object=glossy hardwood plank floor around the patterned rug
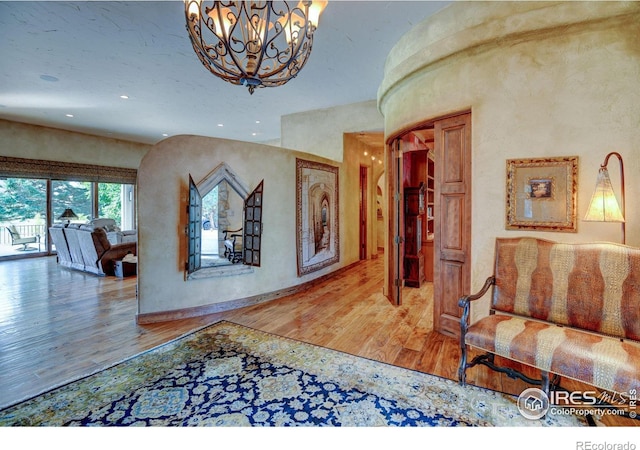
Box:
[0,253,640,426]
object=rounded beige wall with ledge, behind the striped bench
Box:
[378,2,640,324]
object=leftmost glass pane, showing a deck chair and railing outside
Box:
[0,178,47,256]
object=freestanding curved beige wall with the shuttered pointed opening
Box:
[138,136,370,314]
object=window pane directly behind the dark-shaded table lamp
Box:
[51,180,92,223]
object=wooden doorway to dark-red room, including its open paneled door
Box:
[385,112,471,336]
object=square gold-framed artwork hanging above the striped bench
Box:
[506,156,578,233]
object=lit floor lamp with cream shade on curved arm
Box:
[584,152,626,244]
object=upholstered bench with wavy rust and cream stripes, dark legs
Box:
[458,238,640,394]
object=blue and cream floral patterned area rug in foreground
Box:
[0,321,584,427]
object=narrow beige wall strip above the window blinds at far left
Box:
[0,120,151,169]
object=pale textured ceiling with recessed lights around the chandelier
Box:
[0,0,451,144]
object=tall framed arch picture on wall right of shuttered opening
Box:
[296,159,340,276]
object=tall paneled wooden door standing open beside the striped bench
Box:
[433,114,471,337]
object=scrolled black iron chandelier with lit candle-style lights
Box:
[185,0,327,94]
